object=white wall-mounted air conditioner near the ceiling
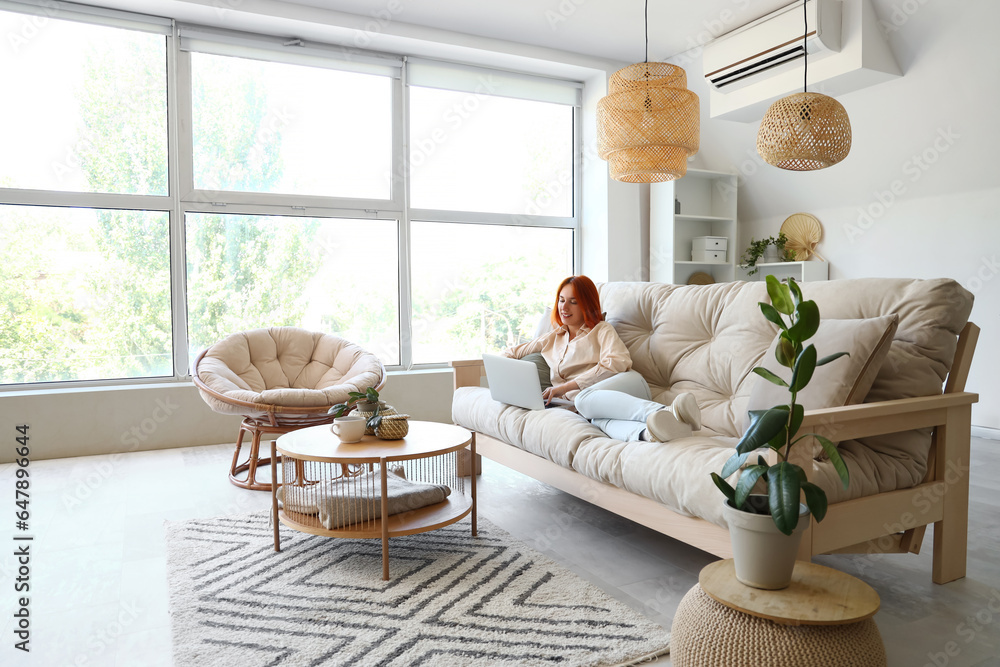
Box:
[704,0,842,93]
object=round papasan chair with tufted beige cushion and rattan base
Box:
[191,327,385,491]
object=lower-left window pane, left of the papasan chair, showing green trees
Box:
[0,205,173,384]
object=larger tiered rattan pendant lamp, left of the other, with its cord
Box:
[597,0,700,183]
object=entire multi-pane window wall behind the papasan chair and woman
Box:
[0,2,579,386]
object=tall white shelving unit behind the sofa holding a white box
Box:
[649,169,740,285]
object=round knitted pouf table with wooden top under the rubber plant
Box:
[670,559,886,667]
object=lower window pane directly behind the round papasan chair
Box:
[187,213,399,365]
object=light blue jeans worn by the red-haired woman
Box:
[573,371,667,442]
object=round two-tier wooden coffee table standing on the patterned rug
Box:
[271,421,477,580]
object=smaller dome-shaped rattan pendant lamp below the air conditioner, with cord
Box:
[757,0,851,171]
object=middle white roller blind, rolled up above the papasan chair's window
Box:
[180,25,403,77]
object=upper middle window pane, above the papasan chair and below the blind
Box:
[191,52,392,199]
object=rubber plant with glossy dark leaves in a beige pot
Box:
[712,275,849,589]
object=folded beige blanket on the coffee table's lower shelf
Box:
[277,467,451,530]
